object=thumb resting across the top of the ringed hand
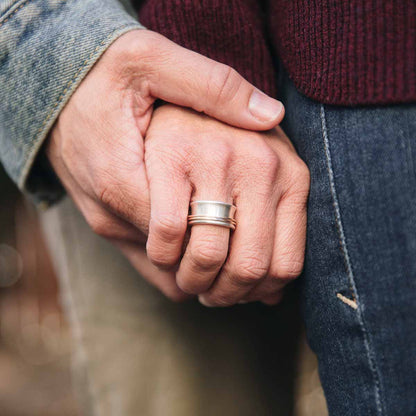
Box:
[143,31,284,130]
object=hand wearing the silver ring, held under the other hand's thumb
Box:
[145,105,309,306]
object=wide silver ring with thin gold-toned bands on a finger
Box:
[188,201,237,230]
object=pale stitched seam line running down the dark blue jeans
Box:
[321,104,383,415]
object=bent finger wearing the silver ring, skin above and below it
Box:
[176,185,232,294]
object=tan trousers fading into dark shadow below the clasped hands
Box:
[41,199,325,416]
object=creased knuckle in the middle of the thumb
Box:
[208,64,241,104]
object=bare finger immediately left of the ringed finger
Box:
[146,149,192,269]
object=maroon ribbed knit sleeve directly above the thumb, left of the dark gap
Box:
[139,0,276,96]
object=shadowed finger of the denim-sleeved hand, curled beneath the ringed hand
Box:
[114,241,191,302]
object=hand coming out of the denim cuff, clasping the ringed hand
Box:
[46,30,284,299]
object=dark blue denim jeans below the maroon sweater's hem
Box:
[280,75,416,416]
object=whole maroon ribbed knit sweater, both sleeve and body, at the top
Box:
[136,0,416,105]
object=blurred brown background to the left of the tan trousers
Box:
[0,165,80,416]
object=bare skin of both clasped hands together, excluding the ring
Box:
[46,30,309,306]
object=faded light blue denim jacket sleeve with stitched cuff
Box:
[0,0,143,205]
